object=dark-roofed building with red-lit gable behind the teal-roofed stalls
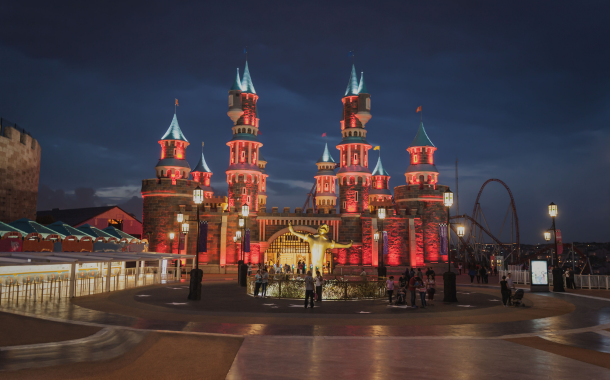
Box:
[36,206,142,239]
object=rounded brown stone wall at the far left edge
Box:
[0,127,41,223]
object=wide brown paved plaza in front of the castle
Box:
[0,275,610,379]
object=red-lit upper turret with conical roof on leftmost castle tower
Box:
[155,114,191,185]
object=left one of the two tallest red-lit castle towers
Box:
[226,62,263,211]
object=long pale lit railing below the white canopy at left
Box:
[0,266,191,305]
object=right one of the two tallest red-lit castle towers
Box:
[337,65,371,213]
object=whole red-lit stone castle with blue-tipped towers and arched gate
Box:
[142,62,448,273]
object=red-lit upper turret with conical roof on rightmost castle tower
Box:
[405,123,438,189]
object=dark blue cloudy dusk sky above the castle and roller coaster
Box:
[0,1,610,243]
